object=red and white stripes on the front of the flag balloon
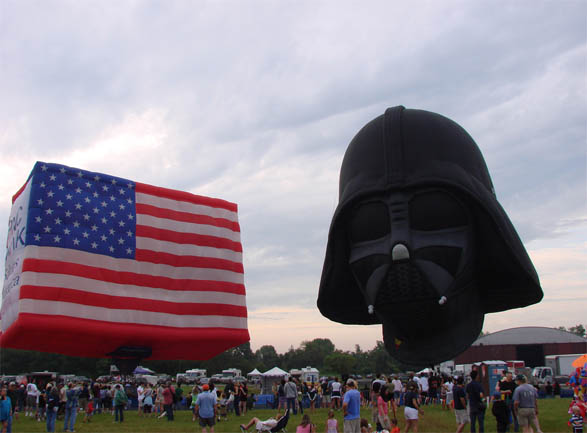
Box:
[13,183,247,330]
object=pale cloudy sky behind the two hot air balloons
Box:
[0,0,587,352]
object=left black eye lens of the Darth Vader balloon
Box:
[348,202,390,242]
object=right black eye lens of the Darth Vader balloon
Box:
[410,191,468,230]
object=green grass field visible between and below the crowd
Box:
[12,398,571,433]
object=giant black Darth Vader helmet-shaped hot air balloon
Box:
[318,106,542,365]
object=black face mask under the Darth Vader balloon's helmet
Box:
[347,189,475,341]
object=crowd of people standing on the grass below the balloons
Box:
[0,370,585,433]
